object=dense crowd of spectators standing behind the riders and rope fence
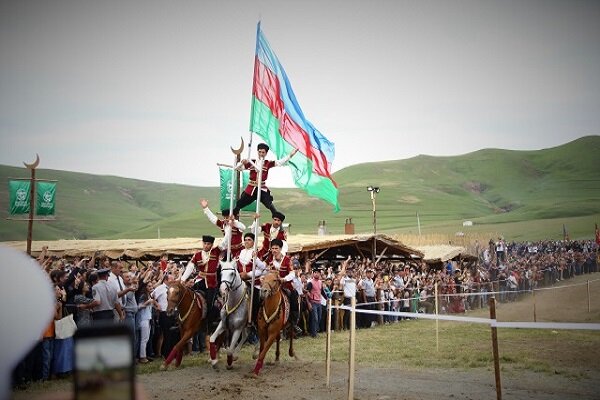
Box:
[13,239,598,390]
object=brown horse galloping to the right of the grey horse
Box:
[254,272,296,375]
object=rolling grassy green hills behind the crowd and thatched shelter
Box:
[0,136,600,240]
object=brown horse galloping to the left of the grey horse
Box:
[160,281,206,370]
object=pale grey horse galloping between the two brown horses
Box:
[210,261,249,369]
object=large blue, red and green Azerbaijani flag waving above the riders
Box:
[250,22,340,212]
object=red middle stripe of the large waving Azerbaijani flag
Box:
[252,57,337,182]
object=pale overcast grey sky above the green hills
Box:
[0,0,600,187]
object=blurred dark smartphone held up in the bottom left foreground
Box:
[73,323,135,400]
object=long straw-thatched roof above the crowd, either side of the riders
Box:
[1,235,423,259]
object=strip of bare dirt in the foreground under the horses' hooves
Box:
[127,359,600,400]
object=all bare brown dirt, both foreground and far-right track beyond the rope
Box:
[12,274,600,400]
